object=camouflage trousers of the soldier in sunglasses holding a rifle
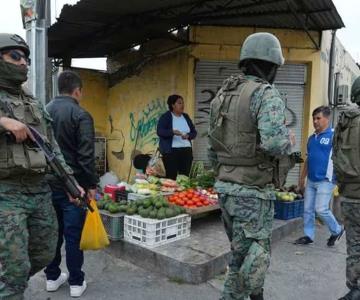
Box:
[0,184,58,300]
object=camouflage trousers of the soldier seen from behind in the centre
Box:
[219,194,274,300]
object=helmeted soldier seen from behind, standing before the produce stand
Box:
[209,33,295,300]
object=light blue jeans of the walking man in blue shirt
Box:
[304,179,341,240]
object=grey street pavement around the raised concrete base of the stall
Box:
[25,226,347,300]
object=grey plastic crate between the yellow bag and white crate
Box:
[99,210,125,241]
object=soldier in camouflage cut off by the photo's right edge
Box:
[333,77,360,300]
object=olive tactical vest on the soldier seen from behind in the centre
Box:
[209,76,274,187]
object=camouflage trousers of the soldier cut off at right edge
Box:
[341,197,360,289]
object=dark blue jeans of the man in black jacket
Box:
[45,191,86,285]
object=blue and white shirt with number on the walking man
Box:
[307,127,335,182]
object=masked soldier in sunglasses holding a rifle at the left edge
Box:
[0,33,76,300]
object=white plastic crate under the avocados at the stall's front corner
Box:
[124,214,191,248]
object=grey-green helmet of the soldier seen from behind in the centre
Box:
[240,32,285,66]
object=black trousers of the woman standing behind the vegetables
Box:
[163,147,193,180]
